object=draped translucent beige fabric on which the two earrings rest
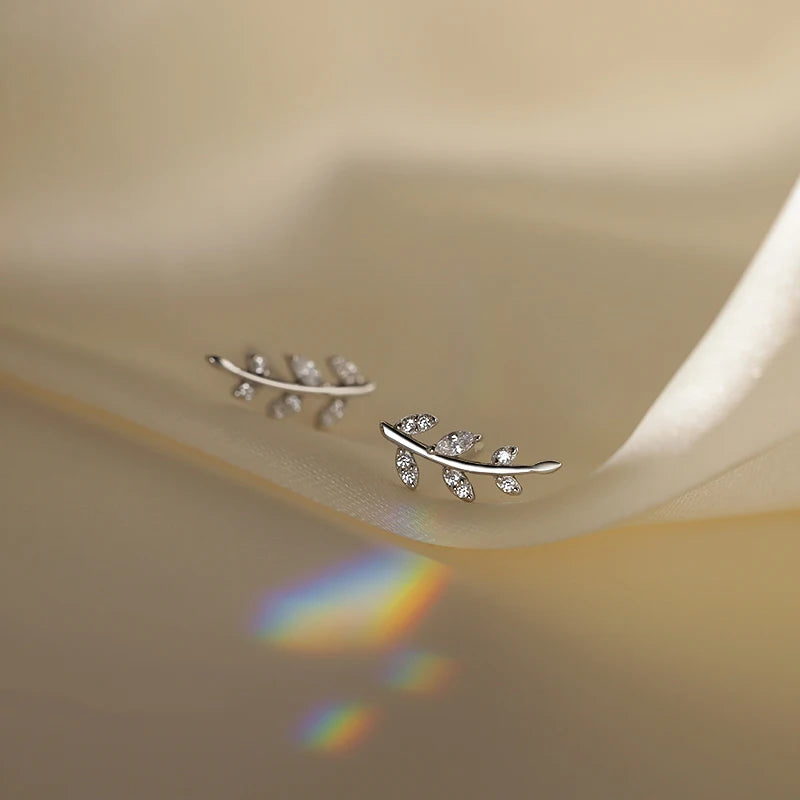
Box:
[0,0,800,547]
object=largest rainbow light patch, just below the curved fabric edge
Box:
[256,548,449,654]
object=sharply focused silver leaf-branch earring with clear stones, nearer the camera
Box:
[381,414,561,503]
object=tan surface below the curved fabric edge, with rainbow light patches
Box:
[0,386,800,800]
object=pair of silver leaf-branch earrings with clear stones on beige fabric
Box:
[207,353,561,503]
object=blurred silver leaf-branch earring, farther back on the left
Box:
[206,353,376,428]
